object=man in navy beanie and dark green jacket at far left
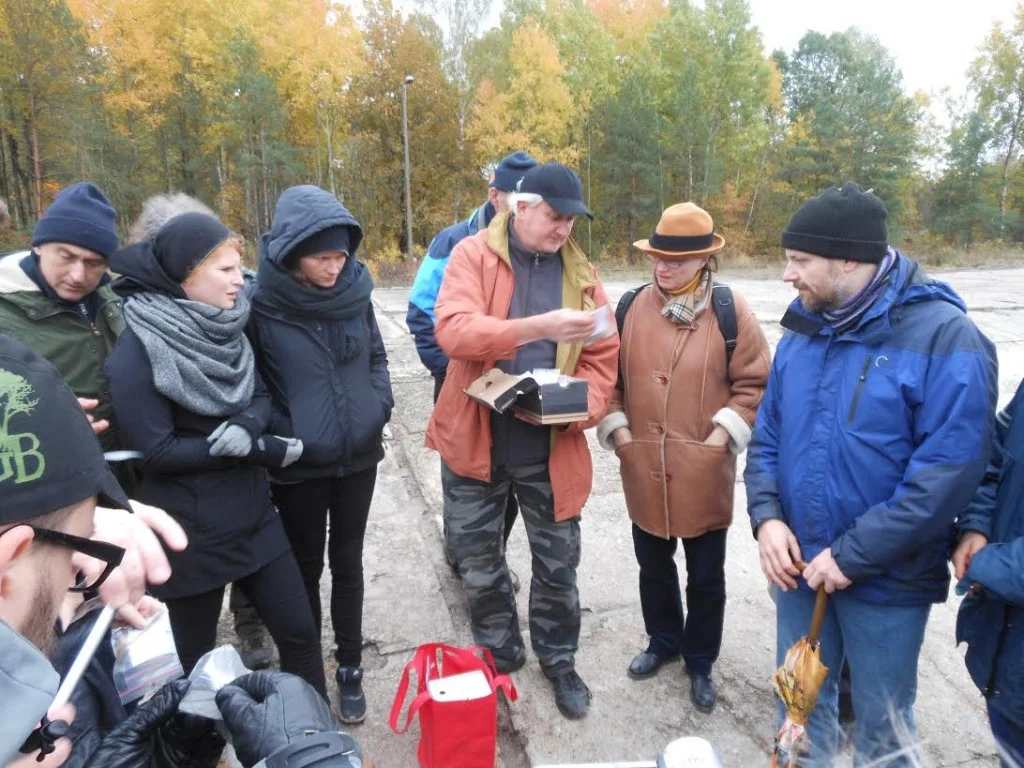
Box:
[0,181,130,462]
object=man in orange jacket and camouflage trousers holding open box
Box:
[426,163,618,719]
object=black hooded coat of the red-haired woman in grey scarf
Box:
[105,234,289,599]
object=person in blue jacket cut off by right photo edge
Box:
[953,383,1024,768]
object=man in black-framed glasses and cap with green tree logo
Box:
[0,336,180,765]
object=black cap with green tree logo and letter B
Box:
[0,336,131,525]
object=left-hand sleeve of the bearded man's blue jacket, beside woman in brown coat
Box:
[743,348,785,537]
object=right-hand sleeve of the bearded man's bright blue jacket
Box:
[831,325,998,582]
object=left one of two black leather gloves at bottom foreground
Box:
[86,680,224,768]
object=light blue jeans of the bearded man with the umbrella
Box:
[776,588,932,768]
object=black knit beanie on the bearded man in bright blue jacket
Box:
[782,183,889,264]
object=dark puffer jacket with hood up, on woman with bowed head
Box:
[249,185,394,482]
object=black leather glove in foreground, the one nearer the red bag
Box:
[216,672,337,768]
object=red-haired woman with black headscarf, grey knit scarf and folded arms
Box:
[106,213,327,697]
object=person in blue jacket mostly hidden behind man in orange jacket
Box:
[406,151,537,591]
